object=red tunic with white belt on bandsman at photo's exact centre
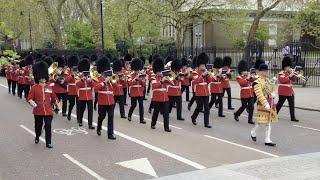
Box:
[151,76,169,102]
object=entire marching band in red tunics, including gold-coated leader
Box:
[1,53,303,148]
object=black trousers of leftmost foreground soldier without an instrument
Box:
[34,115,52,144]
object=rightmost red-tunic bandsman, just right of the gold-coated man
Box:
[276,56,299,122]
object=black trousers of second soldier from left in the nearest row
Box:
[97,105,114,135]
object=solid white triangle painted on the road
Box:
[116,158,158,177]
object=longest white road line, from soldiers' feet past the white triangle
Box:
[71,114,206,169]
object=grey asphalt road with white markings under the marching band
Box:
[0,78,320,180]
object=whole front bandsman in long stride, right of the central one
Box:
[191,53,211,128]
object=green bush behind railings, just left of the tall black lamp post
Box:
[67,23,95,49]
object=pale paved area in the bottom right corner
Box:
[152,152,320,180]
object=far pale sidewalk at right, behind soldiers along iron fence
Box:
[229,81,320,111]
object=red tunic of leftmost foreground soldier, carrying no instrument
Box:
[27,84,58,116]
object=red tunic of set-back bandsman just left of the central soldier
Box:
[128,74,146,97]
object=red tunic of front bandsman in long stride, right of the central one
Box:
[192,70,210,96]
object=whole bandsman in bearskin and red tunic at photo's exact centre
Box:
[151,56,172,132]
